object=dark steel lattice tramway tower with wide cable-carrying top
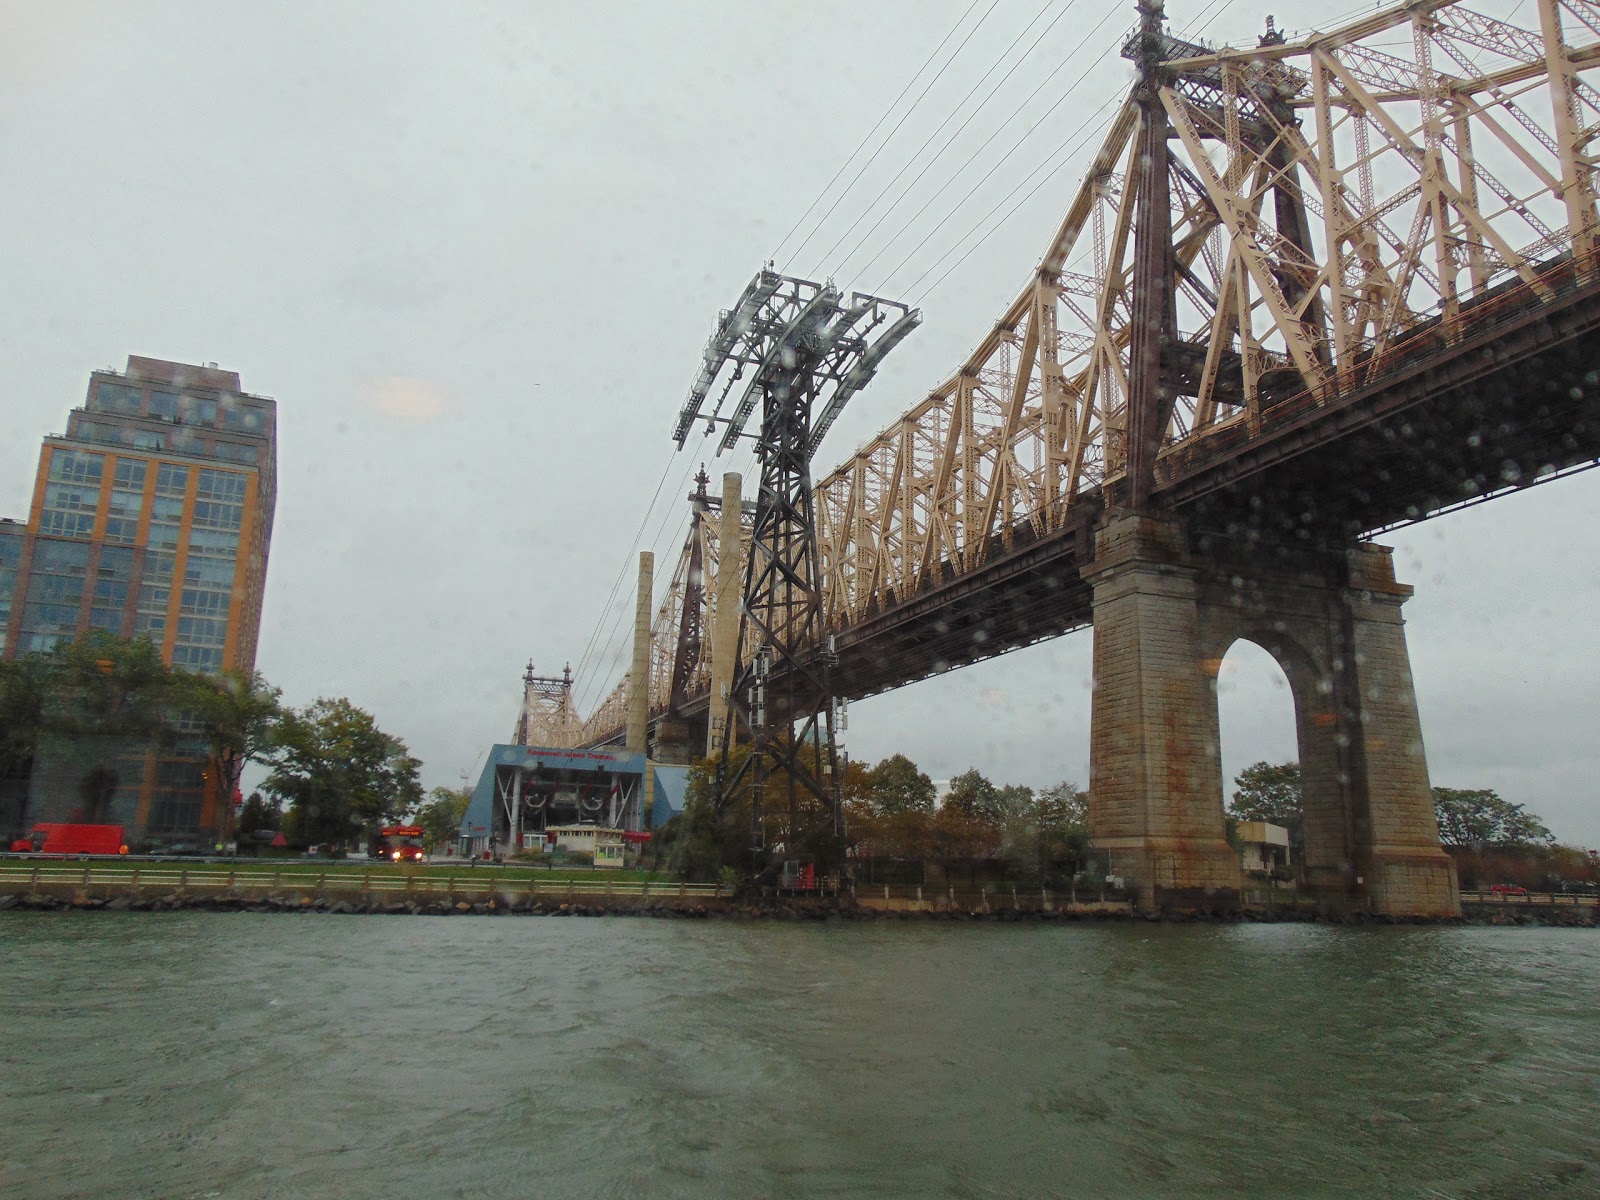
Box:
[674,270,922,875]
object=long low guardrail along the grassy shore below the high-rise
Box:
[0,862,723,899]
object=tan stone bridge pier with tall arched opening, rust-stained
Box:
[1085,514,1461,917]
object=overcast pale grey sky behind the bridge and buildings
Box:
[0,0,1600,845]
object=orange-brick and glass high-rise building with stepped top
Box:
[0,357,277,843]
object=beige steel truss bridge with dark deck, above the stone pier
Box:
[550,0,1600,761]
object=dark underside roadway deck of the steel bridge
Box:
[643,275,1600,732]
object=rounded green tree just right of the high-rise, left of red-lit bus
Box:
[262,698,422,846]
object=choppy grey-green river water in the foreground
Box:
[0,912,1600,1198]
